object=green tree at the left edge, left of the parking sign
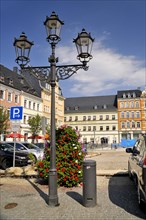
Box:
[0,106,10,134]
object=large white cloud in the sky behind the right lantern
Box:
[57,41,146,96]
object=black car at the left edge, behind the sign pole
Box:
[0,142,29,169]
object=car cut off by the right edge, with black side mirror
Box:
[126,136,146,208]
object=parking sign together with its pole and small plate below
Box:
[10,106,23,167]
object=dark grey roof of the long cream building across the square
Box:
[65,95,117,113]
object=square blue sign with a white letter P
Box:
[10,106,23,120]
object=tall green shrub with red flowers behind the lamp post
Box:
[37,125,84,187]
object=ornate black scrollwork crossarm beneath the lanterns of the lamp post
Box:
[21,64,89,82]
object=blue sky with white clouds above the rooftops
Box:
[0,0,146,97]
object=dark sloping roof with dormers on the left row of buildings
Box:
[0,65,40,97]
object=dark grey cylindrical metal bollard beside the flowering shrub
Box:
[83,160,97,207]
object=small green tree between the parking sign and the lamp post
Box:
[28,114,42,136]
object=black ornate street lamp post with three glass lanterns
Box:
[14,12,94,206]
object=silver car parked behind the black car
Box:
[6,141,44,161]
